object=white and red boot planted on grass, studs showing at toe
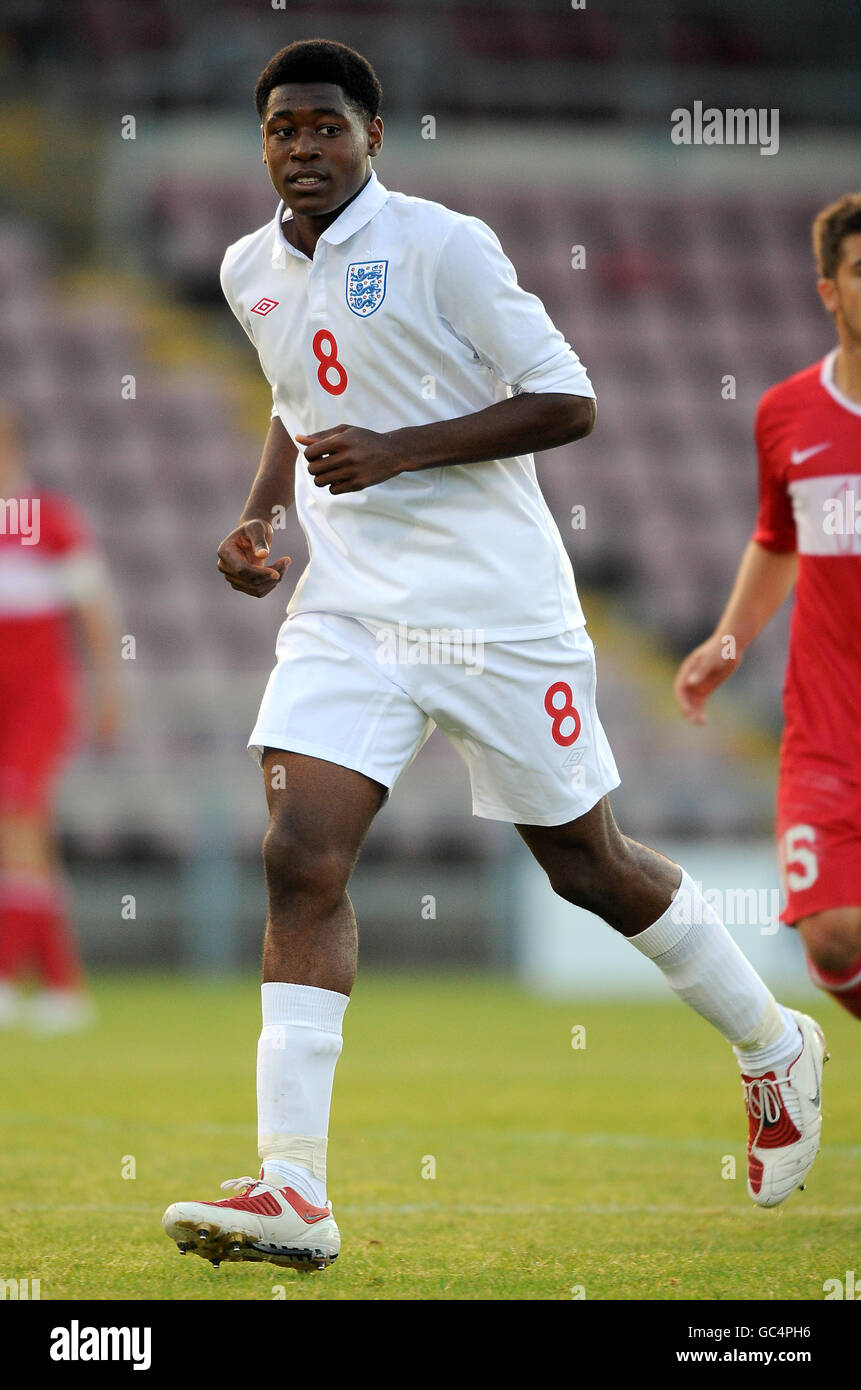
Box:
[161,1177,341,1272]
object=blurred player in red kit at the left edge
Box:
[0,407,118,1033]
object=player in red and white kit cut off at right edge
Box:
[676,193,861,1017]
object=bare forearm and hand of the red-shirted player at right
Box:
[675,541,798,724]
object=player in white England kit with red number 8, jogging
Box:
[163,40,825,1269]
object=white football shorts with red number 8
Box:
[249,613,619,826]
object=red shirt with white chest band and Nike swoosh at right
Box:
[754,349,861,784]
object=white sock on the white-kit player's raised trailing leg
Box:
[629,869,798,1076]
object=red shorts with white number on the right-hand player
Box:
[776,769,861,926]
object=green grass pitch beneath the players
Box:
[0,976,861,1300]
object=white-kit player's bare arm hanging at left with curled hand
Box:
[218,418,298,599]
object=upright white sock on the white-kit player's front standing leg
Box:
[257,984,349,1207]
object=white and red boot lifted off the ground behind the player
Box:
[741,1009,829,1207]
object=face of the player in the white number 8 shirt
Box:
[263,82,383,217]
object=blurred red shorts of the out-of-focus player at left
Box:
[0,673,77,815]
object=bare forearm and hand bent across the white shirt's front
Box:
[296,392,595,493]
